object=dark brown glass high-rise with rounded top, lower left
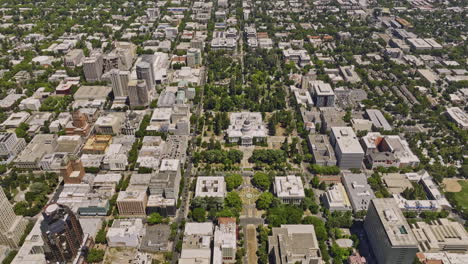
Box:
[41,203,84,263]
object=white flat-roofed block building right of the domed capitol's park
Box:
[330,127,364,169]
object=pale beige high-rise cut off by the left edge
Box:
[0,187,27,248]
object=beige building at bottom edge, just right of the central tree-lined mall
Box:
[268,225,322,264]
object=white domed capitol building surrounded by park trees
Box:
[226,112,267,146]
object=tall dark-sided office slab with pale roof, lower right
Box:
[364,198,419,264]
